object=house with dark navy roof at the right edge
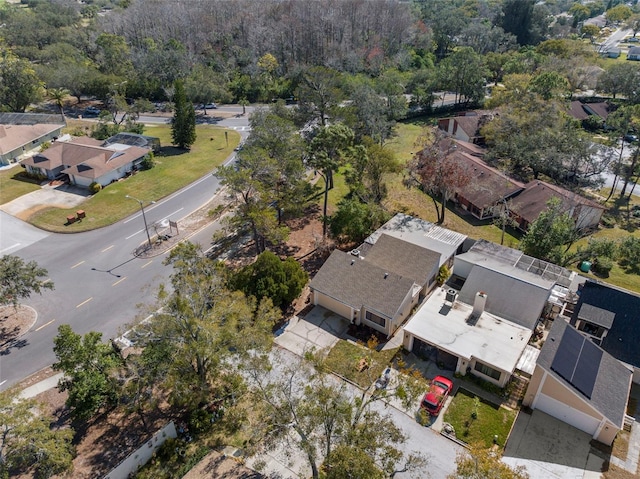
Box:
[571,280,640,384]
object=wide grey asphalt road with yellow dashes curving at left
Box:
[0,108,248,390]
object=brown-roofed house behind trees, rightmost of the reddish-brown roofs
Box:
[509,180,606,231]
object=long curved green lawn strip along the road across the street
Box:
[28,125,240,233]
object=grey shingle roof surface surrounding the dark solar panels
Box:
[538,319,632,427]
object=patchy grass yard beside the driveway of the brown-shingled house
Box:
[325,339,399,389]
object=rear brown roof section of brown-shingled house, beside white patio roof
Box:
[365,234,440,286]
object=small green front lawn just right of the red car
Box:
[444,388,516,448]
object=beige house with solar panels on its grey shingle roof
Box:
[523,319,632,445]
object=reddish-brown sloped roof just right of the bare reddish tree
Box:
[452,151,524,208]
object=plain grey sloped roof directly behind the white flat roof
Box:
[454,265,553,330]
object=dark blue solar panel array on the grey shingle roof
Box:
[551,326,602,399]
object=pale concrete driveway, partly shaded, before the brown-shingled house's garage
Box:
[274,306,349,356]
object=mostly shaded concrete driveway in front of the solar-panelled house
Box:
[502,410,604,479]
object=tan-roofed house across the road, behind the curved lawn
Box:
[22,137,150,187]
